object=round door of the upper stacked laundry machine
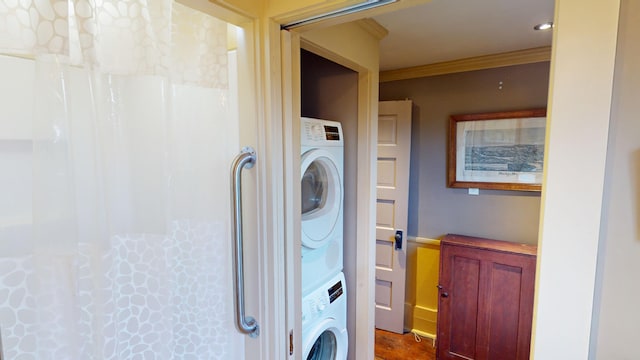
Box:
[300,149,342,249]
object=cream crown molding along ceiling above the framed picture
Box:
[380,46,551,83]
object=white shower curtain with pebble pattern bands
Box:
[0,0,243,360]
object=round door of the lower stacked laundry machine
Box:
[302,318,348,360]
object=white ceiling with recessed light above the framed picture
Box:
[373,0,554,71]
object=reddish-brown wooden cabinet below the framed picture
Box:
[437,235,536,360]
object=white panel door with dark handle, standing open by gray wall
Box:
[376,100,411,333]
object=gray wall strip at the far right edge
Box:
[589,0,640,359]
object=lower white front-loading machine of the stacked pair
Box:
[302,272,349,360]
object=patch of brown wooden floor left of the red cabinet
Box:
[375,329,436,360]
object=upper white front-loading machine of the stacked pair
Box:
[300,117,344,296]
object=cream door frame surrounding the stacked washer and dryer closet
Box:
[281,22,378,359]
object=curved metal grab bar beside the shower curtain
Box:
[231,147,260,337]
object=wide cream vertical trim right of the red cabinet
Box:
[531,0,620,359]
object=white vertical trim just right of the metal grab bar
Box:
[256,20,294,360]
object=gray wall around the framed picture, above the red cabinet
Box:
[380,62,549,244]
